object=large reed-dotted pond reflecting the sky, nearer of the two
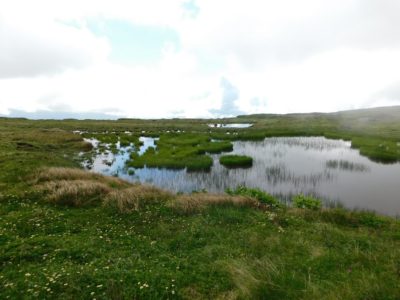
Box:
[83,137,400,216]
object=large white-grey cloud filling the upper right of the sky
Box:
[181,0,400,68]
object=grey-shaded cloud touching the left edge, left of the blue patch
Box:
[0,15,109,79]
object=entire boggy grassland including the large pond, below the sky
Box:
[0,108,400,299]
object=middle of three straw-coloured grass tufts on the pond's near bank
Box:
[104,185,173,213]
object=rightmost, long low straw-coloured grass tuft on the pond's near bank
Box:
[169,193,259,214]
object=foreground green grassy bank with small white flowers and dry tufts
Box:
[0,168,400,299]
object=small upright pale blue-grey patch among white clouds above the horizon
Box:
[209,78,243,117]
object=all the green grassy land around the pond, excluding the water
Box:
[0,107,400,299]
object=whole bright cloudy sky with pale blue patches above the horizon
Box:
[0,0,400,119]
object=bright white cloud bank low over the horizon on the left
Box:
[0,50,219,117]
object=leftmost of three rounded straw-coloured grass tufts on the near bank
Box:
[38,180,111,207]
